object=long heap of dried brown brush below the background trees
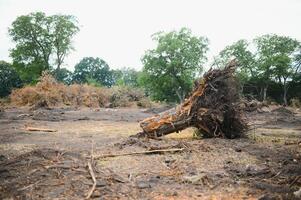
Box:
[10,73,151,110]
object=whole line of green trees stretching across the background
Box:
[0,12,301,105]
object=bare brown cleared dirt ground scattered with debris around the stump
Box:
[0,105,301,199]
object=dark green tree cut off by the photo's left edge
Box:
[0,61,22,97]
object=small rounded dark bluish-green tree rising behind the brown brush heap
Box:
[73,57,114,87]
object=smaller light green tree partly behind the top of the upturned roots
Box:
[214,40,258,92]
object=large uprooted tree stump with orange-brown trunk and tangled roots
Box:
[138,60,247,138]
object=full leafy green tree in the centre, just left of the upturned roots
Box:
[140,28,208,102]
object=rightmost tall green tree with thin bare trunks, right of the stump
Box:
[254,34,300,105]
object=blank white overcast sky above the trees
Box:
[0,0,301,70]
